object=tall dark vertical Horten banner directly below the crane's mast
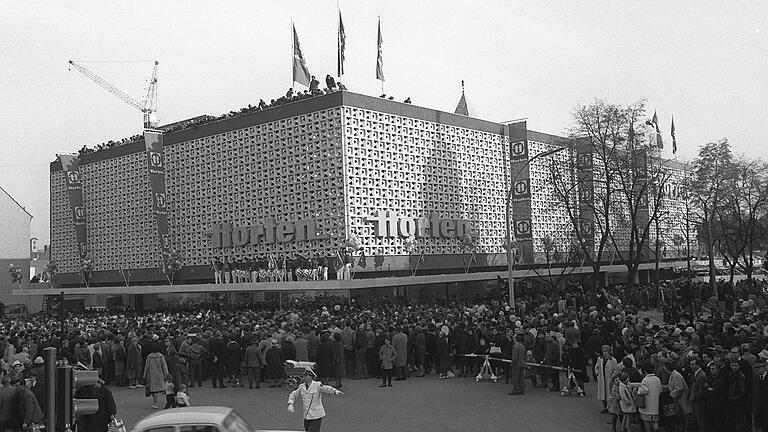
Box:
[144,130,170,256]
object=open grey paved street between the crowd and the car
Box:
[113,376,610,432]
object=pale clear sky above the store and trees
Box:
[0,0,768,245]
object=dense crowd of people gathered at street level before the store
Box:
[0,280,768,432]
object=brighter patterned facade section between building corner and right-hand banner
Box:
[344,107,508,256]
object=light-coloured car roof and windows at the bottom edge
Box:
[131,406,302,432]
